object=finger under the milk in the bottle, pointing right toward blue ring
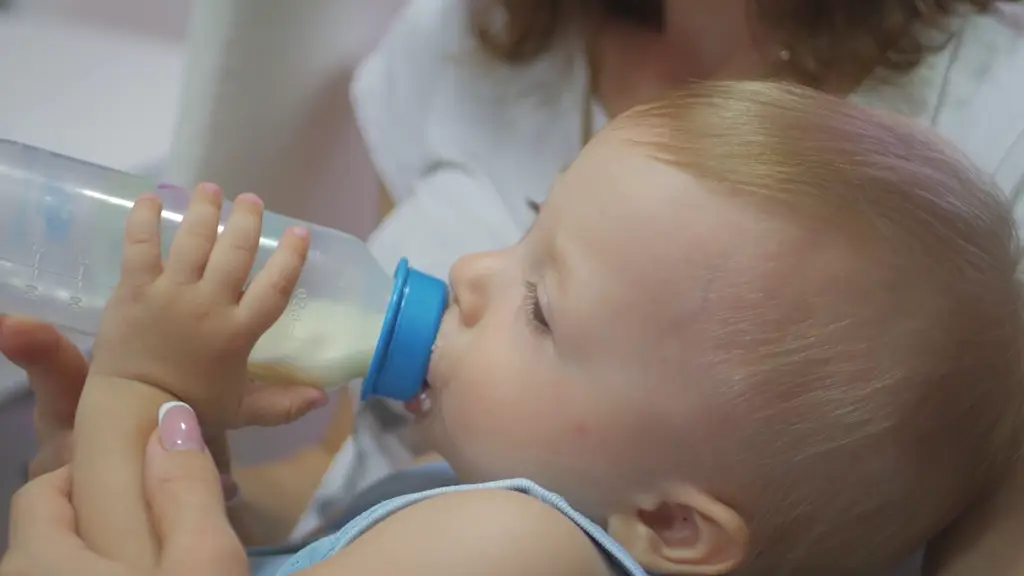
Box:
[239,383,330,426]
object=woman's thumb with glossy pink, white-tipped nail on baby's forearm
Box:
[145,402,245,574]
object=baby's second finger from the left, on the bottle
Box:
[166,184,223,284]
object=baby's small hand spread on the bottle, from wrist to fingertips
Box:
[86,184,309,429]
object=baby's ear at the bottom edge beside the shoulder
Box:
[608,485,750,575]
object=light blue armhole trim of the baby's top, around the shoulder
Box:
[250,480,648,576]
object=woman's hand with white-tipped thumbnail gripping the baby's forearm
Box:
[0,404,249,576]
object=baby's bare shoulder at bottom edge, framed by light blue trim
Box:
[303,490,611,576]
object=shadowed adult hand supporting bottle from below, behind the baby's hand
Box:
[0,316,328,478]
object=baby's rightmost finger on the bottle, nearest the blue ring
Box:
[239,228,309,334]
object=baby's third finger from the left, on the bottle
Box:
[203,194,263,297]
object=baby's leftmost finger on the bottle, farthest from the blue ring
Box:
[121,194,162,286]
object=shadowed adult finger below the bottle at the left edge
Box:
[0,316,89,432]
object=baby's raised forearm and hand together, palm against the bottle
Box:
[72,186,309,573]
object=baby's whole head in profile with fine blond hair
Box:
[423,83,1024,575]
